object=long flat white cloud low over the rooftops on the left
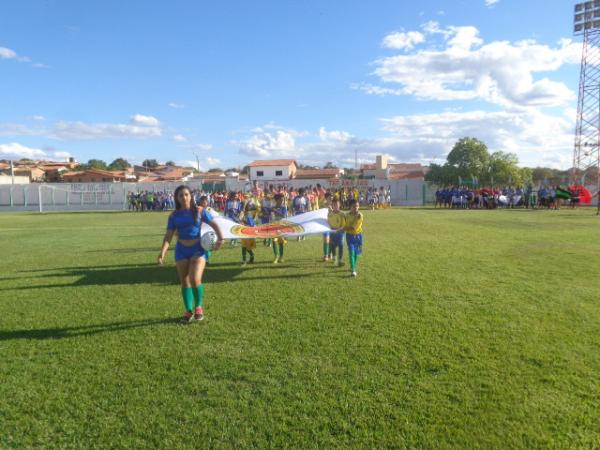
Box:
[50,121,162,139]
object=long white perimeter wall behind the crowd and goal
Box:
[0,180,434,211]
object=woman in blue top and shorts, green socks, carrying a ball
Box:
[158,186,223,323]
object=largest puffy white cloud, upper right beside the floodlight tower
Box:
[366,22,580,107]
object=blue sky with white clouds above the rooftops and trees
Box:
[0,0,580,169]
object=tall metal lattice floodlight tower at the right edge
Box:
[572,0,600,187]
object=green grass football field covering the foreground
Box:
[0,209,600,449]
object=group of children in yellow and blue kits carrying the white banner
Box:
[224,188,363,276]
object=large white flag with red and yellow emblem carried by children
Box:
[202,208,331,239]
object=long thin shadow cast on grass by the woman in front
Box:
[0,318,178,342]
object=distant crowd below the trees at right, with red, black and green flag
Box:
[435,185,592,209]
